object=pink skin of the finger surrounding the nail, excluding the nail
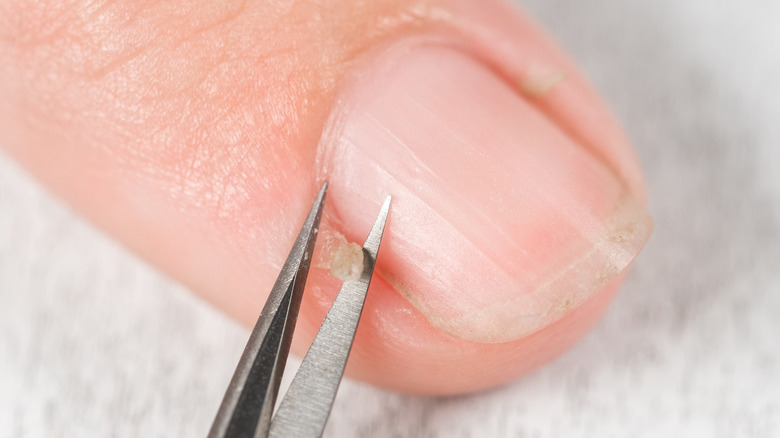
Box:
[0,0,649,394]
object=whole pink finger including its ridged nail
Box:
[0,0,651,394]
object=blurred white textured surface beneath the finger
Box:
[0,0,780,437]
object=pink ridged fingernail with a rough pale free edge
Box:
[317,46,652,342]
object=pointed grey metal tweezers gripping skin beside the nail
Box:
[208,182,390,438]
